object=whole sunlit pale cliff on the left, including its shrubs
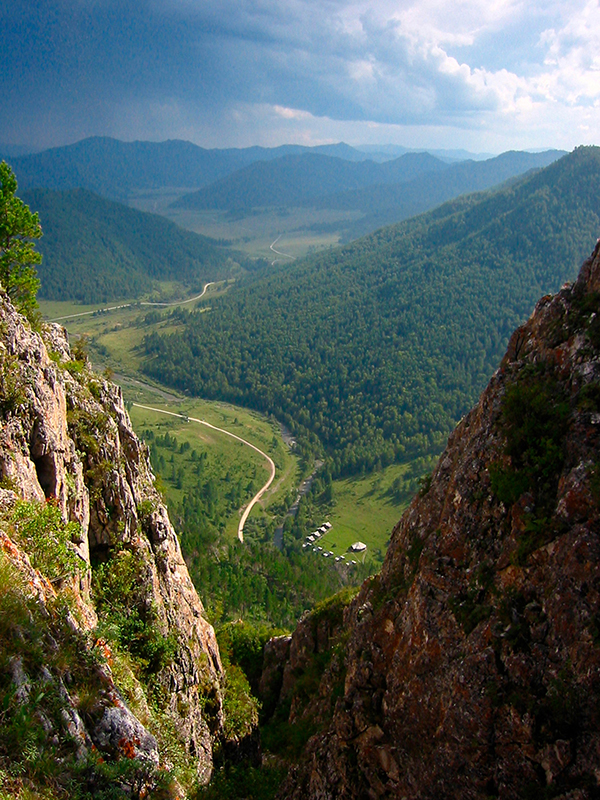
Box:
[0,296,223,796]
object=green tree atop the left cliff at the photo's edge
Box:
[0,161,42,319]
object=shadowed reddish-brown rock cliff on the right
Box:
[280,247,600,800]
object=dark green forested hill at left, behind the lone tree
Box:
[23,189,239,303]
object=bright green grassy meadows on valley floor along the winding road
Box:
[40,290,422,563]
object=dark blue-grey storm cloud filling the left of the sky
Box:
[0,0,490,147]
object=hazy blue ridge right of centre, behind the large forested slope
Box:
[172,150,565,239]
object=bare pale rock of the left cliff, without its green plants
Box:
[0,297,223,780]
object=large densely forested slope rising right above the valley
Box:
[146,147,600,474]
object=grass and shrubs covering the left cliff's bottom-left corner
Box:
[0,492,173,800]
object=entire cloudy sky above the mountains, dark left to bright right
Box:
[0,0,600,153]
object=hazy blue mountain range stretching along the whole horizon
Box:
[2,137,564,250]
